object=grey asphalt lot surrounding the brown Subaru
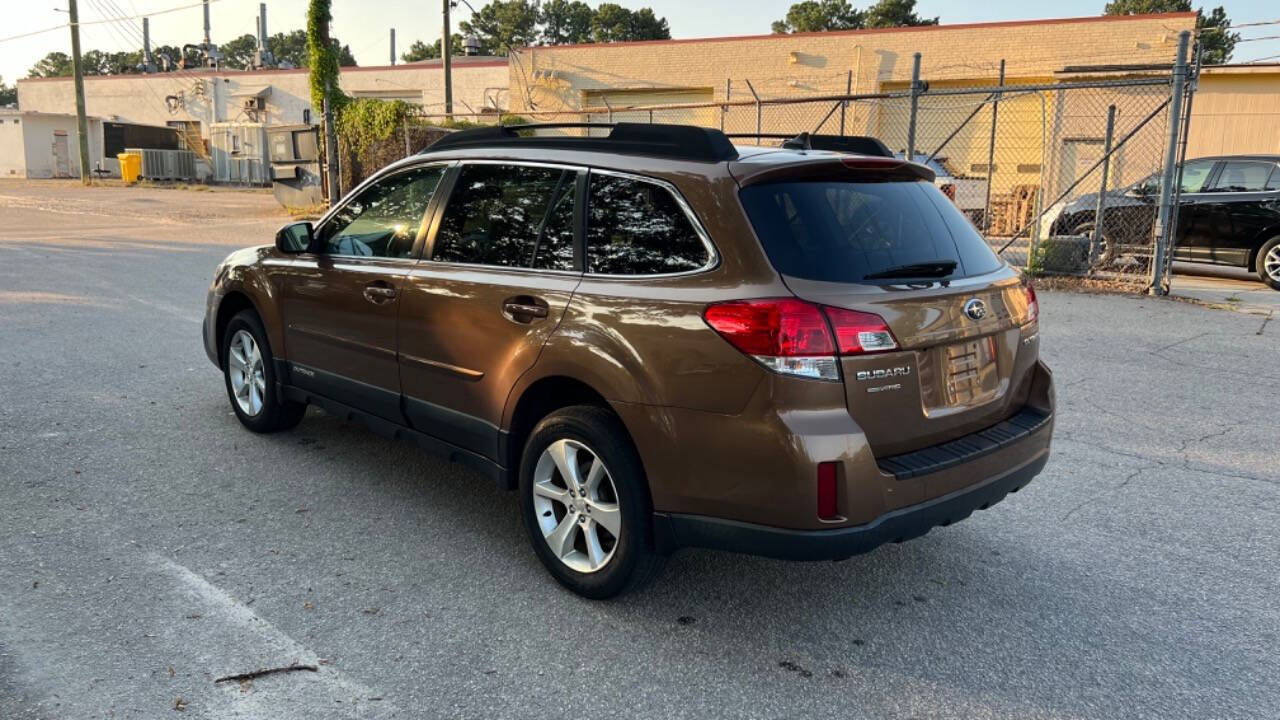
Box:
[0,182,1280,720]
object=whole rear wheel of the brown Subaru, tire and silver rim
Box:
[520,405,664,600]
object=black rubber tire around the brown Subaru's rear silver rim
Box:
[520,405,666,600]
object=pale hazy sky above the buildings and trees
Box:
[0,0,1280,85]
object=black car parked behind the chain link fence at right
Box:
[1047,155,1280,290]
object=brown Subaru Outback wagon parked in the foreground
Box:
[204,124,1053,598]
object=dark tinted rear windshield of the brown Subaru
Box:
[741,181,1001,282]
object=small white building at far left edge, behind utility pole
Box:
[0,110,102,178]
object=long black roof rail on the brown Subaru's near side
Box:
[422,123,737,163]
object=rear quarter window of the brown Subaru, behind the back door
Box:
[586,172,712,275]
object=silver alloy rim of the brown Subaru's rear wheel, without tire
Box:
[532,439,622,573]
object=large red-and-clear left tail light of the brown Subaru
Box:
[703,297,897,380]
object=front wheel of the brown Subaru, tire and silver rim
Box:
[221,310,307,433]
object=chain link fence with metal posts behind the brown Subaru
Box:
[344,33,1194,292]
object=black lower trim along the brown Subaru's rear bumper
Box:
[654,448,1048,560]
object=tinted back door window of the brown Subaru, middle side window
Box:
[431,164,579,270]
